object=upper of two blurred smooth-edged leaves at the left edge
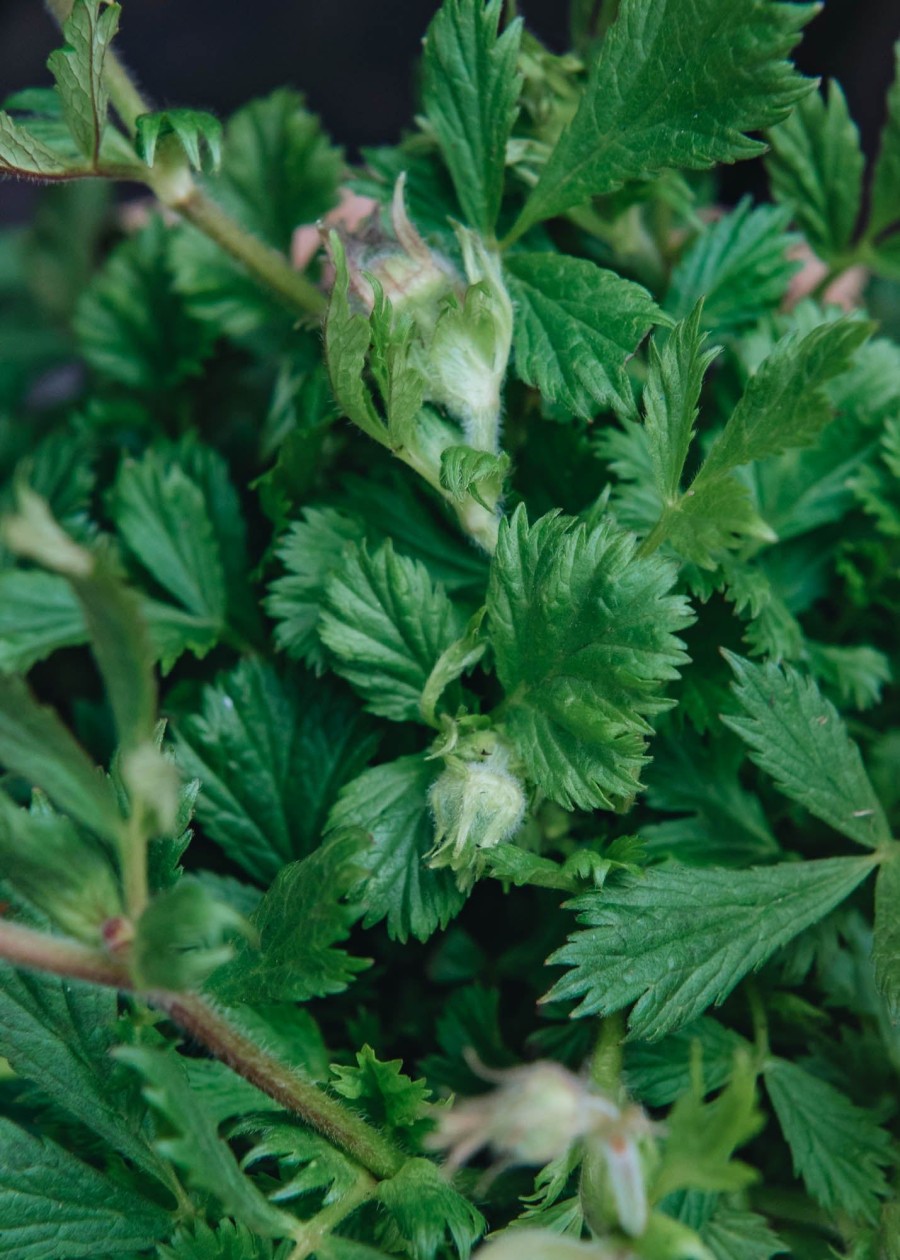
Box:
[0,674,122,843]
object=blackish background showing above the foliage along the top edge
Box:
[0,0,900,221]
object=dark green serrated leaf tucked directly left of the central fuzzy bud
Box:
[328,755,465,941]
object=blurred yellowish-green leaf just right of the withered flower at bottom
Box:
[653,1045,765,1200]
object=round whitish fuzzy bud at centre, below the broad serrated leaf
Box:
[429,745,526,886]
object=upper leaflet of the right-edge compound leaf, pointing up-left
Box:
[722,653,891,848]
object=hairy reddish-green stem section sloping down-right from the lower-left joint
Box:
[153,992,406,1179]
